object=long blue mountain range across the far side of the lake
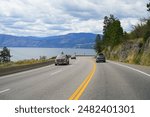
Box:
[0,33,96,48]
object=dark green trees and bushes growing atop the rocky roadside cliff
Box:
[95,2,150,53]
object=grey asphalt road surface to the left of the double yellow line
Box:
[0,57,93,100]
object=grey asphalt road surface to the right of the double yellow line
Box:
[80,61,150,100]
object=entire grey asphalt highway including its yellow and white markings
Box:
[0,57,150,100]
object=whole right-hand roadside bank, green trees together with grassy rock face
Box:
[95,2,150,65]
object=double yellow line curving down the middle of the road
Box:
[69,61,96,100]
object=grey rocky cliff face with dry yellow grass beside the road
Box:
[104,38,150,65]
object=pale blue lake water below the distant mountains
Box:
[2,47,96,61]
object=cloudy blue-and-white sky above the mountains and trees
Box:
[0,0,149,37]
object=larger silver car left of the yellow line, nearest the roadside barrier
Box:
[55,54,69,65]
